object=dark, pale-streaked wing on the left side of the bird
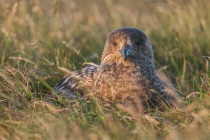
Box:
[54,64,99,99]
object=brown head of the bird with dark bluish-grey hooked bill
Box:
[101,27,153,63]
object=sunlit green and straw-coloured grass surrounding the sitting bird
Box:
[0,0,210,140]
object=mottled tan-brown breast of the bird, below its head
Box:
[93,63,150,102]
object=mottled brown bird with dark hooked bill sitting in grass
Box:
[54,27,184,111]
